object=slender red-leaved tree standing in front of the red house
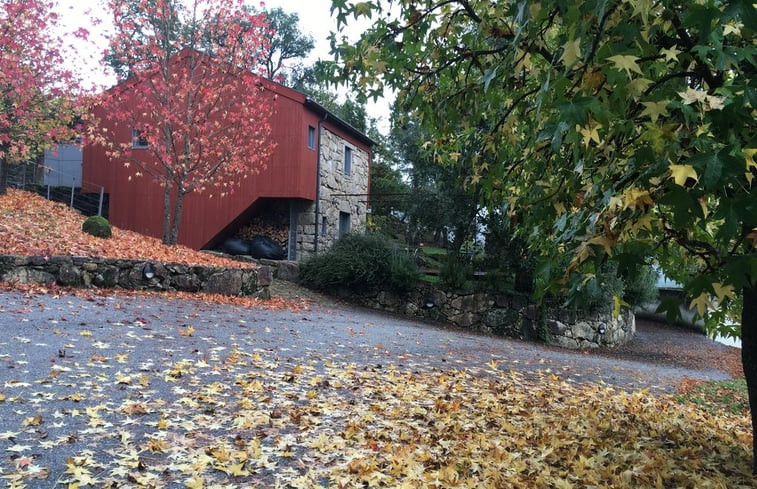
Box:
[94,0,273,244]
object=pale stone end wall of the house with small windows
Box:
[297,128,370,260]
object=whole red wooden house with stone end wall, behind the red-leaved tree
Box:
[82,75,373,259]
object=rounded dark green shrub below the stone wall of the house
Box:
[300,233,419,293]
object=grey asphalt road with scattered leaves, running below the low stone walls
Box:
[0,291,727,487]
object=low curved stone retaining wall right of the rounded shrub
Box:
[352,287,636,349]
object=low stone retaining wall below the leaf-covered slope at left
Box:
[0,255,272,297]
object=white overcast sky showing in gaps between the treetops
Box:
[58,0,388,127]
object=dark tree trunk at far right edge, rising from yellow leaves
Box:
[741,283,757,475]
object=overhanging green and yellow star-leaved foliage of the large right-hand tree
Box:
[332,0,757,469]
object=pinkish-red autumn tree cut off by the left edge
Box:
[0,0,84,194]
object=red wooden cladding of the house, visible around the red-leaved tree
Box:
[82,81,319,248]
